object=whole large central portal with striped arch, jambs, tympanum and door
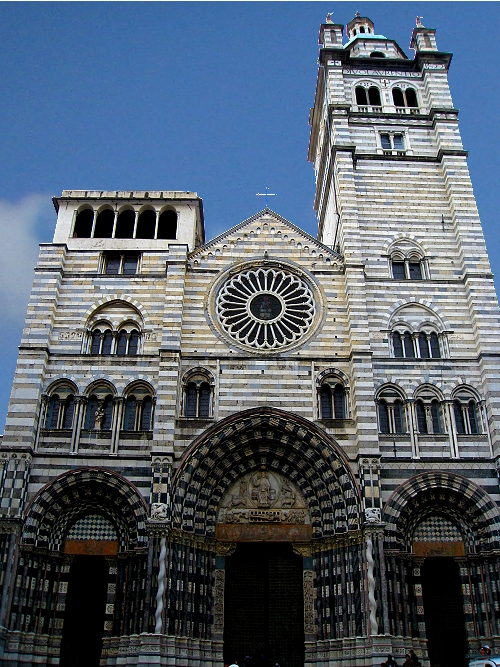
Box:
[172,408,365,667]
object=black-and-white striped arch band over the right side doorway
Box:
[383,471,500,553]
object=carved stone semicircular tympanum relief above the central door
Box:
[218,468,310,524]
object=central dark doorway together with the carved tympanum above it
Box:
[215,465,312,667]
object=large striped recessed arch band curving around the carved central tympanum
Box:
[172,407,361,538]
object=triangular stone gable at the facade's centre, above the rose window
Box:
[189,208,343,266]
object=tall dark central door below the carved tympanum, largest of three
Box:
[224,543,304,667]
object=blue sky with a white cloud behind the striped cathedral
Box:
[0,2,500,432]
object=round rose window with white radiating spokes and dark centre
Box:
[216,268,315,350]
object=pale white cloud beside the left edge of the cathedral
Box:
[0,194,55,328]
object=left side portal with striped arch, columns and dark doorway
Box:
[10,468,151,667]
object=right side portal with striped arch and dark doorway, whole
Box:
[383,471,500,667]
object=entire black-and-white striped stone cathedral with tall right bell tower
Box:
[0,16,500,667]
